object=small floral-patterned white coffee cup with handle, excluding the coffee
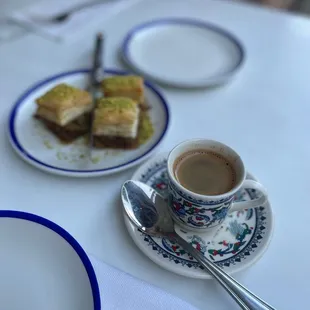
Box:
[167,139,267,232]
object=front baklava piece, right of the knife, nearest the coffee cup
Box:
[93,97,140,149]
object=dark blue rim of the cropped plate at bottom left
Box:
[0,210,101,310]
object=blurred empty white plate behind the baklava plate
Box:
[122,18,244,87]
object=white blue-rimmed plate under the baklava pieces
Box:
[9,70,169,177]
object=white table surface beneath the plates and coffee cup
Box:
[0,0,310,310]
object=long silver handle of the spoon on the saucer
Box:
[169,234,275,310]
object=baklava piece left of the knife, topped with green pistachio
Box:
[35,84,93,143]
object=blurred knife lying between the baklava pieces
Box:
[88,33,104,159]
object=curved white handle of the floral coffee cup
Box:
[229,180,268,213]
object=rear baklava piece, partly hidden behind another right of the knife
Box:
[101,75,144,105]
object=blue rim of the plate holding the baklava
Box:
[9,69,170,174]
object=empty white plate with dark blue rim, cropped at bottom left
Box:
[0,210,101,310]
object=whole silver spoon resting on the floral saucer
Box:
[121,181,275,310]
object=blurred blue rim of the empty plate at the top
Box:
[121,17,245,86]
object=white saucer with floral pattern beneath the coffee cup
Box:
[124,154,273,279]
